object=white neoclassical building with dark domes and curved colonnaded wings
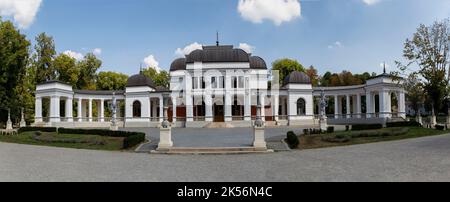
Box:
[35,45,406,127]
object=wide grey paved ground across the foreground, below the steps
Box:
[0,135,450,181]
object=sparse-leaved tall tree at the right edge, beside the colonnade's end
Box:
[396,19,450,111]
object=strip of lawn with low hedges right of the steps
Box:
[299,127,449,149]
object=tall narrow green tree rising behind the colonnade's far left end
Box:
[33,33,56,83]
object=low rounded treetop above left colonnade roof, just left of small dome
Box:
[97,72,128,90]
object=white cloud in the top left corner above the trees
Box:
[0,0,42,28]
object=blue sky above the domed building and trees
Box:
[0,0,450,75]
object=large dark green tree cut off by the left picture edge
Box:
[0,19,31,122]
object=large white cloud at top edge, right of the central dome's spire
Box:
[238,0,301,25]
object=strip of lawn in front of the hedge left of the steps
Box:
[0,132,124,151]
